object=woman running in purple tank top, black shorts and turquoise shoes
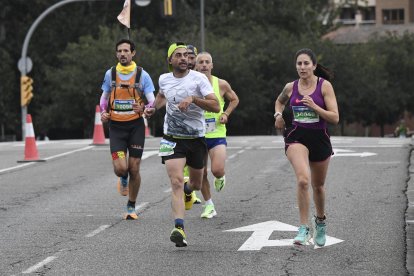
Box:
[274,49,339,246]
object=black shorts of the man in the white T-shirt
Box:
[162,135,207,169]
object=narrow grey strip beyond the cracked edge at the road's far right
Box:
[405,137,414,275]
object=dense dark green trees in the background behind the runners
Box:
[0,0,414,138]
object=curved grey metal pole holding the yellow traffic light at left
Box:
[19,0,108,141]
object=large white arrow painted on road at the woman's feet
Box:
[225,220,343,251]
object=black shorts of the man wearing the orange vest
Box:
[109,117,145,158]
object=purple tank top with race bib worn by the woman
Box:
[290,78,326,129]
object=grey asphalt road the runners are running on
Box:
[0,136,414,275]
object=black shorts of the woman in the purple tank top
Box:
[283,125,333,162]
